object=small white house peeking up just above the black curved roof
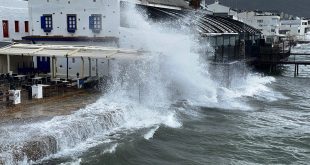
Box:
[207,0,239,20]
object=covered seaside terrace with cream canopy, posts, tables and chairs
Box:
[0,43,143,105]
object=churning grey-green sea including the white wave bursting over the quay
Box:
[0,3,310,165]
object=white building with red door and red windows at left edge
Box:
[0,0,29,41]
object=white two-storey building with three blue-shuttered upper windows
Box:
[15,0,120,77]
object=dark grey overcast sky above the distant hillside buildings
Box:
[206,0,310,18]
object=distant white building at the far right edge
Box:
[280,19,310,40]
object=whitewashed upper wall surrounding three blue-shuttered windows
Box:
[29,0,120,37]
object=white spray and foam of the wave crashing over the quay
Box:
[0,2,284,164]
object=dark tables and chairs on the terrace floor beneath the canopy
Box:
[0,71,99,108]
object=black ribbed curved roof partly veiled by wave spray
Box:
[142,7,261,35]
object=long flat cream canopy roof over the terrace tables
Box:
[0,44,142,59]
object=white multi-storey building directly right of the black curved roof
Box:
[238,11,280,42]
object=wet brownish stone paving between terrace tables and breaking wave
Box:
[0,90,101,125]
